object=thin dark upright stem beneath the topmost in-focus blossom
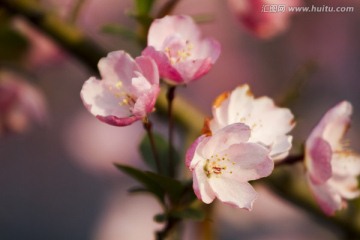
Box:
[166,86,176,176]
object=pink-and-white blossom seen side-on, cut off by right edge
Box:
[305,101,360,215]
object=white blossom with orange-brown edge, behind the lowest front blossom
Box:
[209,85,295,160]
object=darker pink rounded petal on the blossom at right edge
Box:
[306,138,332,184]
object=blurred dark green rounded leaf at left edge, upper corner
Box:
[0,24,29,61]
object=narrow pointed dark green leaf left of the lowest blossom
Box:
[115,163,165,203]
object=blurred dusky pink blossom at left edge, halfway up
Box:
[0,72,46,135]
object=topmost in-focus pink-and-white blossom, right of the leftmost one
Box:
[142,16,220,84]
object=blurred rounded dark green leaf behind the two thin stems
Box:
[139,134,181,176]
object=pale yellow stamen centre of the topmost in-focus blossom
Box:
[165,40,194,65]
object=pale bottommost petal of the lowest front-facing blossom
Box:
[209,177,257,210]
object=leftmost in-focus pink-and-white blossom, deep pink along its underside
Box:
[81,51,160,126]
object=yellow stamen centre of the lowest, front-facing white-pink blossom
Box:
[204,154,236,178]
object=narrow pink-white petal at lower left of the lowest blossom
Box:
[193,164,215,203]
